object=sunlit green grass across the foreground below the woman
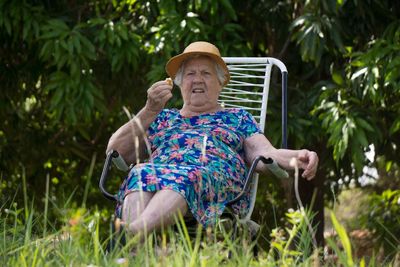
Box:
[0,170,400,267]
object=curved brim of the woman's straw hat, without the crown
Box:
[165,51,230,86]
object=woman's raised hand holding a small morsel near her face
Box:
[145,79,172,114]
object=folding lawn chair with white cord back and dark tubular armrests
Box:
[99,57,288,253]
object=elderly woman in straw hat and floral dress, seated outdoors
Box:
[107,42,318,238]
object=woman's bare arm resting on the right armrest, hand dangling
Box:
[244,134,318,180]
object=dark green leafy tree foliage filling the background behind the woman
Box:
[0,0,400,211]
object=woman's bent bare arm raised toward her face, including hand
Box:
[107,81,172,164]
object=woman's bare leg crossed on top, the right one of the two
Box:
[127,189,188,237]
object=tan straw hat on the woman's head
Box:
[165,42,230,86]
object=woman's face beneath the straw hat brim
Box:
[181,57,222,112]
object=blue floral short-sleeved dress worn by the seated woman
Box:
[116,109,261,226]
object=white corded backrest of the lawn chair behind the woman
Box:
[219,57,287,223]
